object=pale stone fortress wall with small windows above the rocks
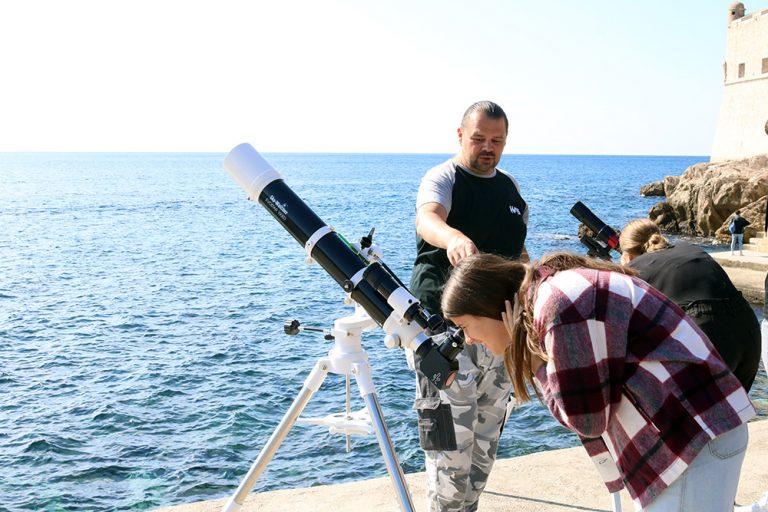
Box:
[710,3,768,162]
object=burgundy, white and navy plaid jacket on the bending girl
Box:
[533,269,755,507]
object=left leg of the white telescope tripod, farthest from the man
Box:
[222,359,329,512]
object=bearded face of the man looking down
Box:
[458,112,507,174]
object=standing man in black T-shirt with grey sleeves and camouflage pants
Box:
[411,101,528,512]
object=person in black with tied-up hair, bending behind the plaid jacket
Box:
[619,219,760,391]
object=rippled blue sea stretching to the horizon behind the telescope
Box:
[0,154,768,511]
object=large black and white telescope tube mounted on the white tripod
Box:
[224,143,463,389]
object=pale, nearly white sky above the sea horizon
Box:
[0,0,744,155]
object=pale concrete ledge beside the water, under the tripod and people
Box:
[157,421,768,512]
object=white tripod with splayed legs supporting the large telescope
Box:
[222,304,414,512]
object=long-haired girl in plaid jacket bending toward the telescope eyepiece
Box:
[442,253,755,512]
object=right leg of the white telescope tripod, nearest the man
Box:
[352,364,414,512]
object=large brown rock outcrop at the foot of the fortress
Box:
[649,155,768,240]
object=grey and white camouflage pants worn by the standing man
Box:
[417,345,511,512]
